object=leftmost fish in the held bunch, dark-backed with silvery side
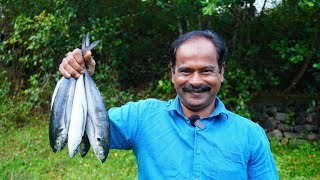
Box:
[49,77,76,153]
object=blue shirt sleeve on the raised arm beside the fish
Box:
[108,101,146,150]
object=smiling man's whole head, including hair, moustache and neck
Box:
[169,31,227,117]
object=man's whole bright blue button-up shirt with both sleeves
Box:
[109,96,278,180]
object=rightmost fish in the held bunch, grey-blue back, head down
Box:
[84,68,110,163]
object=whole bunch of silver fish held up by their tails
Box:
[49,34,110,163]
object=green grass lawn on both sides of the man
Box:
[0,116,320,180]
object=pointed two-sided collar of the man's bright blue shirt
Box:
[167,96,228,118]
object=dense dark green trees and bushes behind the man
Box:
[0,0,320,125]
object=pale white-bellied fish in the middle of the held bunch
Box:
[68,75,87,158]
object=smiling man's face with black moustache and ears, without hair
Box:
[172,37,224,113]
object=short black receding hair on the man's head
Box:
[168,30,228,70]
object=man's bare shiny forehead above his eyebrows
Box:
[176,37,218,66]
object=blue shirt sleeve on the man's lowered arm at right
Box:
[247,124,279,180]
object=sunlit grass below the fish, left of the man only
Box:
[0,114,137,179]
